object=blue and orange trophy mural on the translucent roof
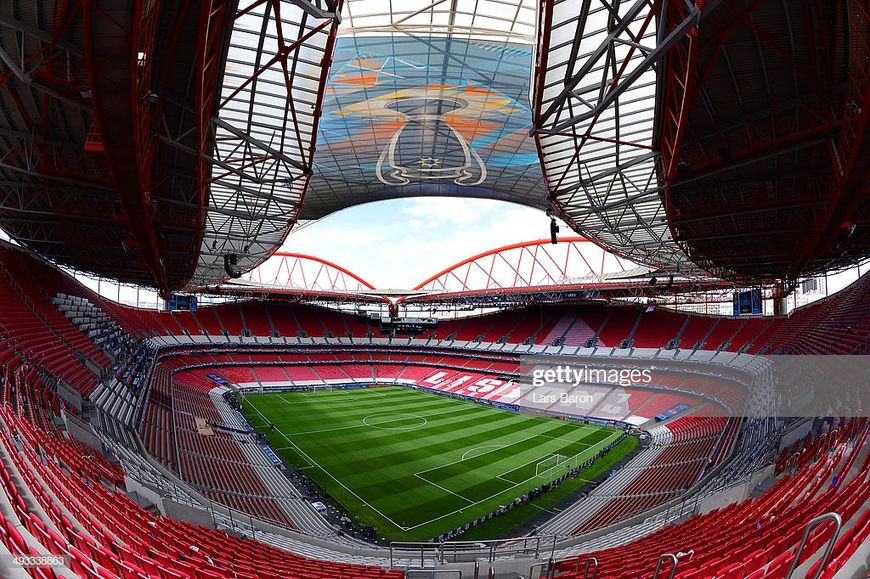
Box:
[305,37,546,216]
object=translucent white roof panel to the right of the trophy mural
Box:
[536,0,697,272]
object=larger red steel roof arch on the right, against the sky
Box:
[414,237,635,292]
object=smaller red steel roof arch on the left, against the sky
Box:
[243,251,375,294]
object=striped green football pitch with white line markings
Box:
[243,387,620,540]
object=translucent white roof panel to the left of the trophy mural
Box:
[190,1,336,286]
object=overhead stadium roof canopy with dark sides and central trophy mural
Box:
[0,0,870,293]
